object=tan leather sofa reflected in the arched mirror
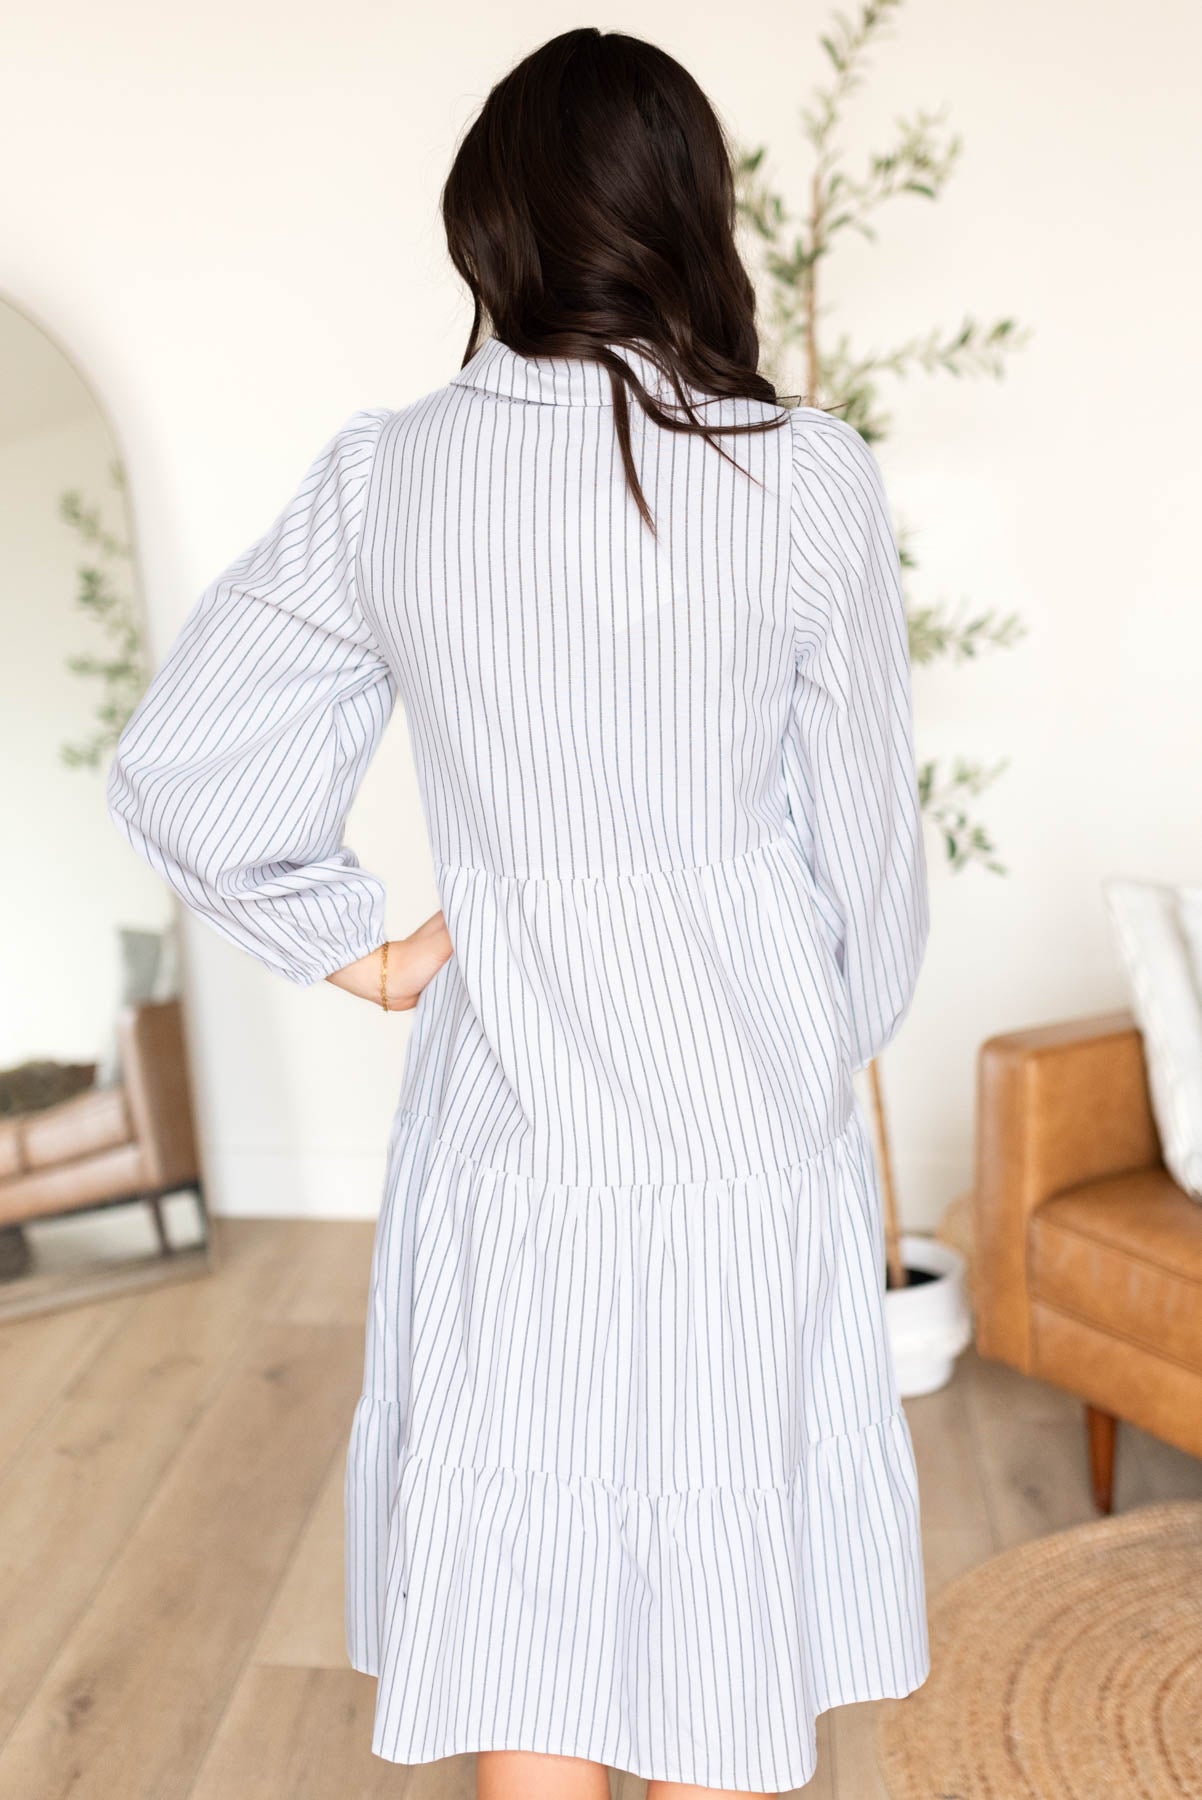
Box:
[0,1001,203,1249]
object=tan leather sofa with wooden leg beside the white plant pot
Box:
[973,1013,1202,1512]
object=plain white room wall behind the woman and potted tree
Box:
[0,0,1202,1222]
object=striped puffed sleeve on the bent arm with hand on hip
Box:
[108,412,396,983]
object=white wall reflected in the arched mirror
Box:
[0,405,171,1067]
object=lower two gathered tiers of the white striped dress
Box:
[345,1102,928,1793]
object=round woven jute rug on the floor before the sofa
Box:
[876,1501,1202,1800]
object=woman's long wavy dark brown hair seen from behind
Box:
[443,27,786,529]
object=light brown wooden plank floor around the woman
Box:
[0,1220,1202,1800]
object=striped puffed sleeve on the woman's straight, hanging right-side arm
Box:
[785,407,928,1069]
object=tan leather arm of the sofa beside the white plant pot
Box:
[973,1012,1161,1370]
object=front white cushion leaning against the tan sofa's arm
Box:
[1103,878,1202,1201]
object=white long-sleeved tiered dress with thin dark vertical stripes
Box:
[110,340,927,1791]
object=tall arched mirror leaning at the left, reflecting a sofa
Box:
[0,301,209,1318]
